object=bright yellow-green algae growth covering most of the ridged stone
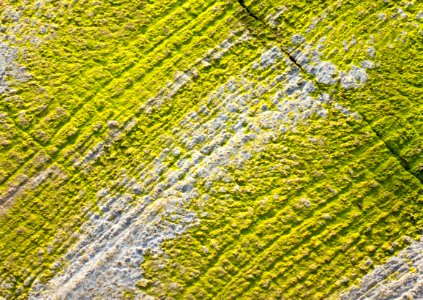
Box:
[0,1,422,299]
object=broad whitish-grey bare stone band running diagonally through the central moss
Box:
[31,41,344,299]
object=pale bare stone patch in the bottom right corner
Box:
[341,239,423,300]
